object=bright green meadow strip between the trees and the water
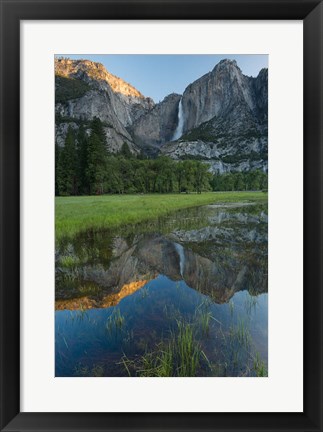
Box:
[55,192,267,241]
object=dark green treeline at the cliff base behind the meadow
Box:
[55,118,268,196]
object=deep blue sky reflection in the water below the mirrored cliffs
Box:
[56,276,268,376]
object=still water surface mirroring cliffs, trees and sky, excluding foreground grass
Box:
[55,205,268,376]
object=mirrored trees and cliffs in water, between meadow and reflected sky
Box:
[56,206,268,308]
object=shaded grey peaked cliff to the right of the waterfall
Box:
[162,60,268,173]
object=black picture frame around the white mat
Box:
[0,0,323,432]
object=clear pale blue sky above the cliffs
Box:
[57,54,268,102]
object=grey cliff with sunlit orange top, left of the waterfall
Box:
[55,59,155,151]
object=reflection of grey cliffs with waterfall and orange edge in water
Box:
[56,207,267,309]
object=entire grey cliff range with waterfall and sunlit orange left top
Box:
[55,59,268,173]
